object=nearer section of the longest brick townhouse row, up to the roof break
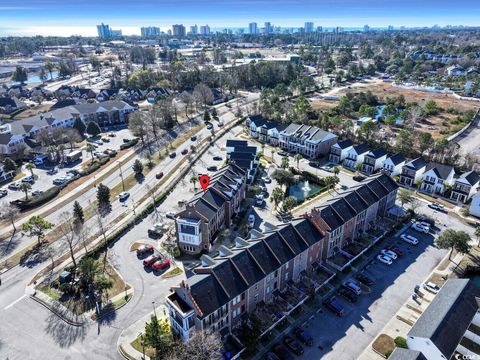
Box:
[166,219,323,340]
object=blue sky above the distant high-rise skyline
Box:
[0,0,480,36]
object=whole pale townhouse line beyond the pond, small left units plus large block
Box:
[246,115,337,159]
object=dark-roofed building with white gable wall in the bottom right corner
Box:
[389,279,480,360]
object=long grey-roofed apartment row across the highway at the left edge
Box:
[0,101,135,157]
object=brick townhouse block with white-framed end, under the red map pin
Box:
[175,163,247,254]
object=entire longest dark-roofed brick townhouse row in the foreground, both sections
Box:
[166,175,398,340]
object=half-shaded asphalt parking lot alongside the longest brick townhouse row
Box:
[262,222,446,360]
